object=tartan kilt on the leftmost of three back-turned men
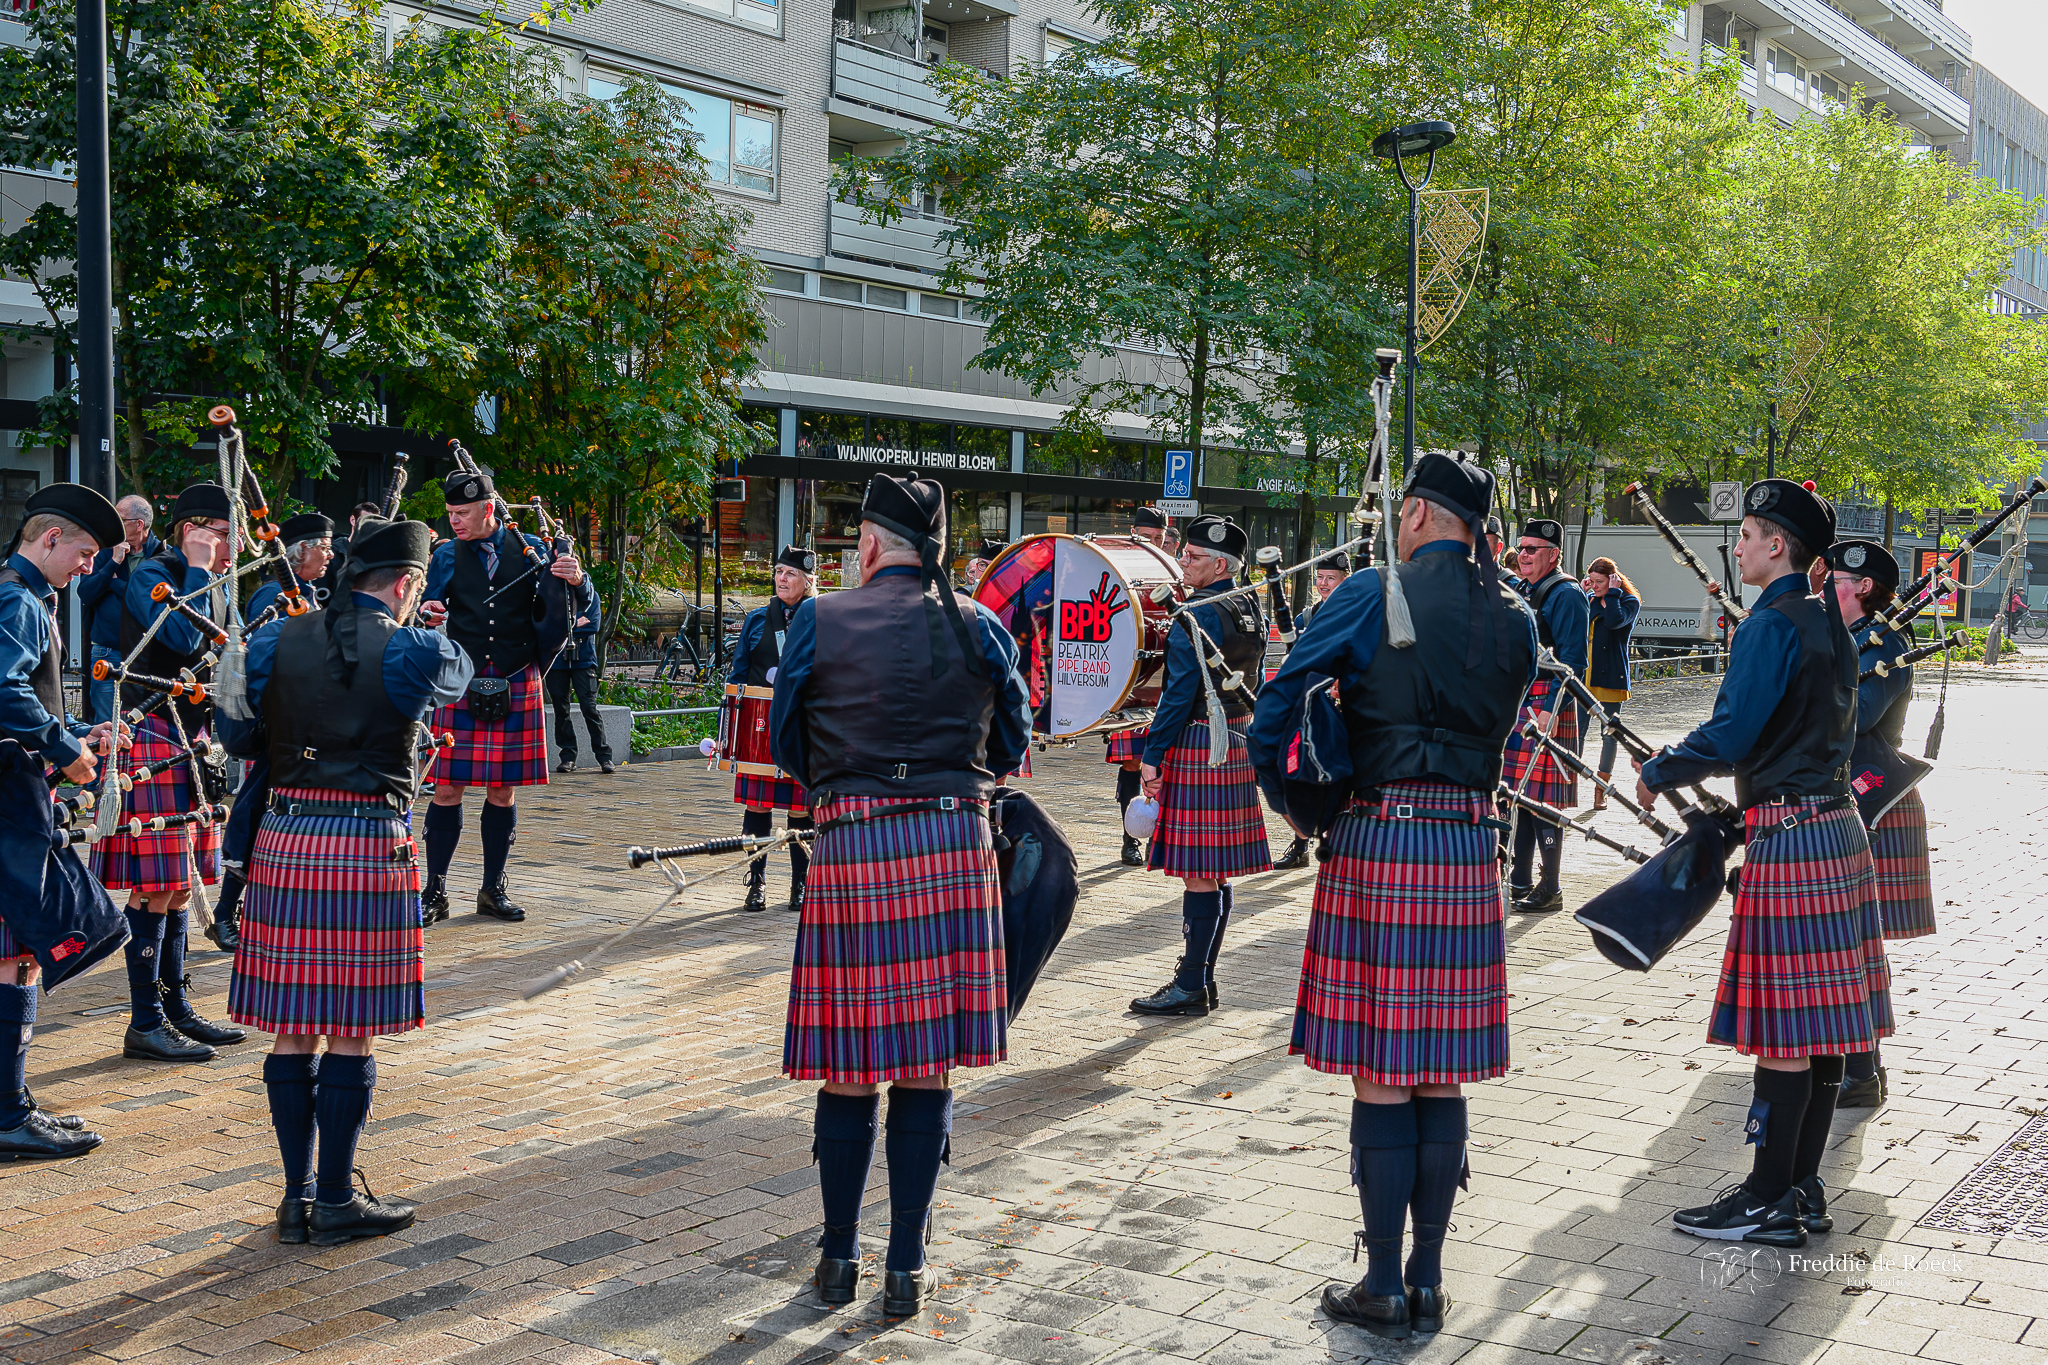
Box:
[227,788,426,1038]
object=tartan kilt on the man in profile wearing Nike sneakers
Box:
[1706,798,1892,1058]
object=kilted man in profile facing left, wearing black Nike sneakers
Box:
[1638,479,1892,1246]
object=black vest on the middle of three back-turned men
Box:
[801,573,995,800]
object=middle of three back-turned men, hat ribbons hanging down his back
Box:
[768,475,1030,1314]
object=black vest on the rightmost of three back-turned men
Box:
[1339,553,1534,792]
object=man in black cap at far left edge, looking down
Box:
[0,483,123,1160]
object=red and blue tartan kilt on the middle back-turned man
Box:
[782,796,1010,1085]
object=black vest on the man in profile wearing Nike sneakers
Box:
[1735,591,1855,810]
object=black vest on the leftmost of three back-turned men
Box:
[262,606,420,804]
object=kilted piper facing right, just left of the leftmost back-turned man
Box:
[92,483,246,1062]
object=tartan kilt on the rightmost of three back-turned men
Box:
[1288,780,1507,1085]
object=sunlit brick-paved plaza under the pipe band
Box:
[0,665,2048,1365]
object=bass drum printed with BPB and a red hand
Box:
[975,534,1186,739]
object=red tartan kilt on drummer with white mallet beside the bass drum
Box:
[1145,716,1274,878]
